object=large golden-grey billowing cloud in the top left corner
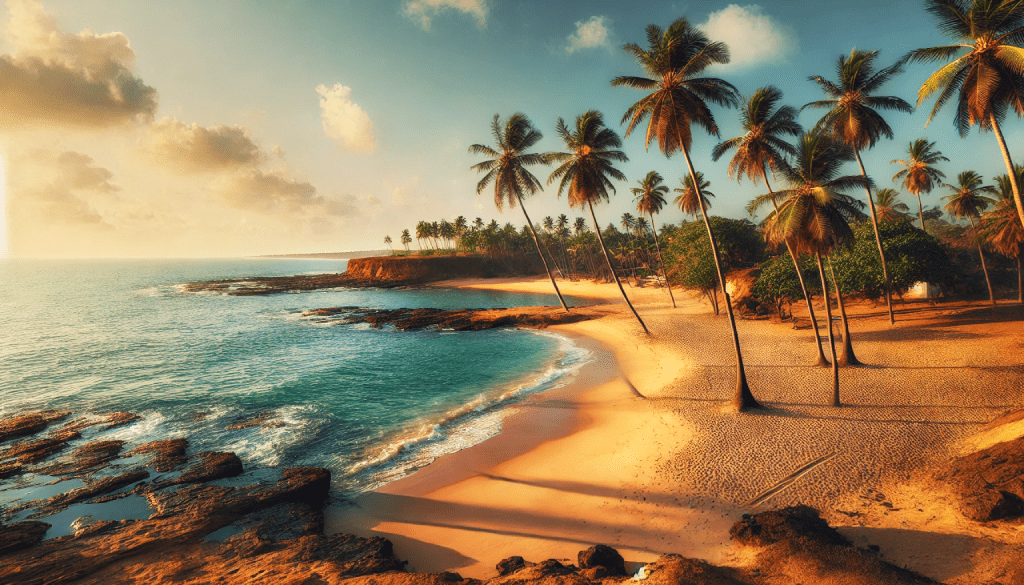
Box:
[0,0,157,127]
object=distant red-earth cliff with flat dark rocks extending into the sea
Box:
[185,256,544,296]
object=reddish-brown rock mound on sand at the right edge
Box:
[939,437,1024,521]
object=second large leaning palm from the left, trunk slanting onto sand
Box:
[548,110,650,335]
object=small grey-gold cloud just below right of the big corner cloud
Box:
[144,118,266,174]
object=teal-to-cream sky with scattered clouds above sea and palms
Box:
[0,0,1024,257]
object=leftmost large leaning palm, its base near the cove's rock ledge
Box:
[469,113,569,312]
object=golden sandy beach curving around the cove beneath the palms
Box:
[328,279,1024,584]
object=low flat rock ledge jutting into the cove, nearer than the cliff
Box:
[302,306,602,331]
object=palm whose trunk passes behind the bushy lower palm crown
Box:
[712,85,828,366]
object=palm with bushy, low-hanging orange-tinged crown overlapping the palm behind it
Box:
[750,132,870,407]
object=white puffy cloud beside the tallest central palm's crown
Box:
[698,4,798,69]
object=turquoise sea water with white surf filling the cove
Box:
[0,259,589,503]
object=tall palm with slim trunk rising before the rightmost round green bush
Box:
[804,49,913,324]
